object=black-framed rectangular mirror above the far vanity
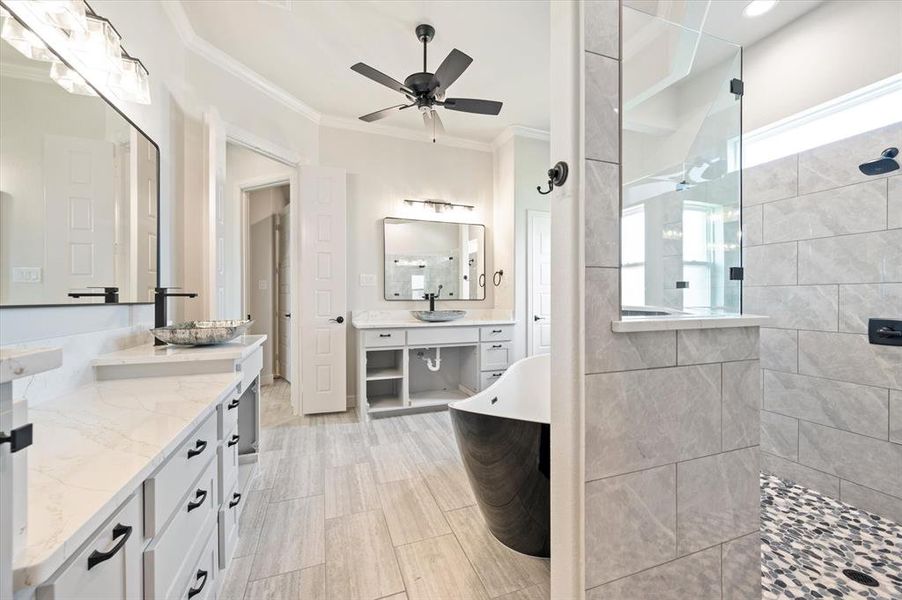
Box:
[384,217,486,300]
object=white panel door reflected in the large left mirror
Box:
[44,135,116,303]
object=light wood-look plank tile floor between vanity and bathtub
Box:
[219,380,549,600]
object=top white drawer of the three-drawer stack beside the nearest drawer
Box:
[144,413,217,538]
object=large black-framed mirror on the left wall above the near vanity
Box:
[0,21,159,306]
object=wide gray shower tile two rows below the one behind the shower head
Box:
[799,229,902,284]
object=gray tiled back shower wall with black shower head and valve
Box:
[743,123,902,522]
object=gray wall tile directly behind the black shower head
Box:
[799,123,902,194]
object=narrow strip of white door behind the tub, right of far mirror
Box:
[526,210,551,356]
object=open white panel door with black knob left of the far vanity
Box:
[297,167,348,415]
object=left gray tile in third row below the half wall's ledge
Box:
[586,465,676,587]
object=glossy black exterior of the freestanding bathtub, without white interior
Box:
[451,407,551,558]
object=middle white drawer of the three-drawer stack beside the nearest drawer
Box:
[144,460,217,600]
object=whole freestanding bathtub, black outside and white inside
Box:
[449,354,551,558]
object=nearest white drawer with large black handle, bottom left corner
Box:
[35,490,142,600]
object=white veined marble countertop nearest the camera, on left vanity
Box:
[13,373,241,589]
